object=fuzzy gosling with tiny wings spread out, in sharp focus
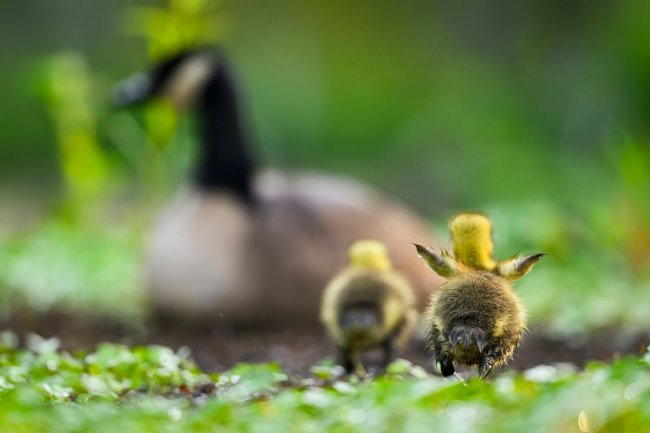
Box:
[416,213,543,379]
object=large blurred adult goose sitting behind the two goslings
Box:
[114,48,438,328]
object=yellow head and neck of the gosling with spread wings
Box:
[449,213,495,270]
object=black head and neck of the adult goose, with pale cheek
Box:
[113,48,255,203]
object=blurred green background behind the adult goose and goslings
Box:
[0,0,650,335]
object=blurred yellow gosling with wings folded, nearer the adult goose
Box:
[321,240,417,375]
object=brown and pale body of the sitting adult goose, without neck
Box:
[145,171,441,328]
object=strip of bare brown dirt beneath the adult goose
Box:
[0,311,650,374]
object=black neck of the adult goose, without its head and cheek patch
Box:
[195,65,254,203]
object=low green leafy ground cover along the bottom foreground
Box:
[0,334,650,433]
